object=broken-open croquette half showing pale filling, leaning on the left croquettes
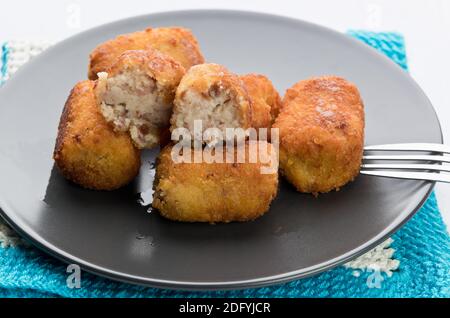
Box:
[97,49,185,149]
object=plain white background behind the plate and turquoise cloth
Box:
[0,0,450,225]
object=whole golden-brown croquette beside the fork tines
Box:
[274,76,364,194]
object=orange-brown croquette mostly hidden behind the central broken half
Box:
[240,74,281,128]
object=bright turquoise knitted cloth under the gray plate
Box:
[0,31,450,297]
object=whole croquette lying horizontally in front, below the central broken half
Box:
[152,143,278,223]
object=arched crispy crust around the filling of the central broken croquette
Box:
[171,63,252,130]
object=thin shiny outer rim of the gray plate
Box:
[0,9,443,291]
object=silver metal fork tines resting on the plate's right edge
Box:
[360,143,450,183]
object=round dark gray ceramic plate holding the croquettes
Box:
[0,11,442,289]
